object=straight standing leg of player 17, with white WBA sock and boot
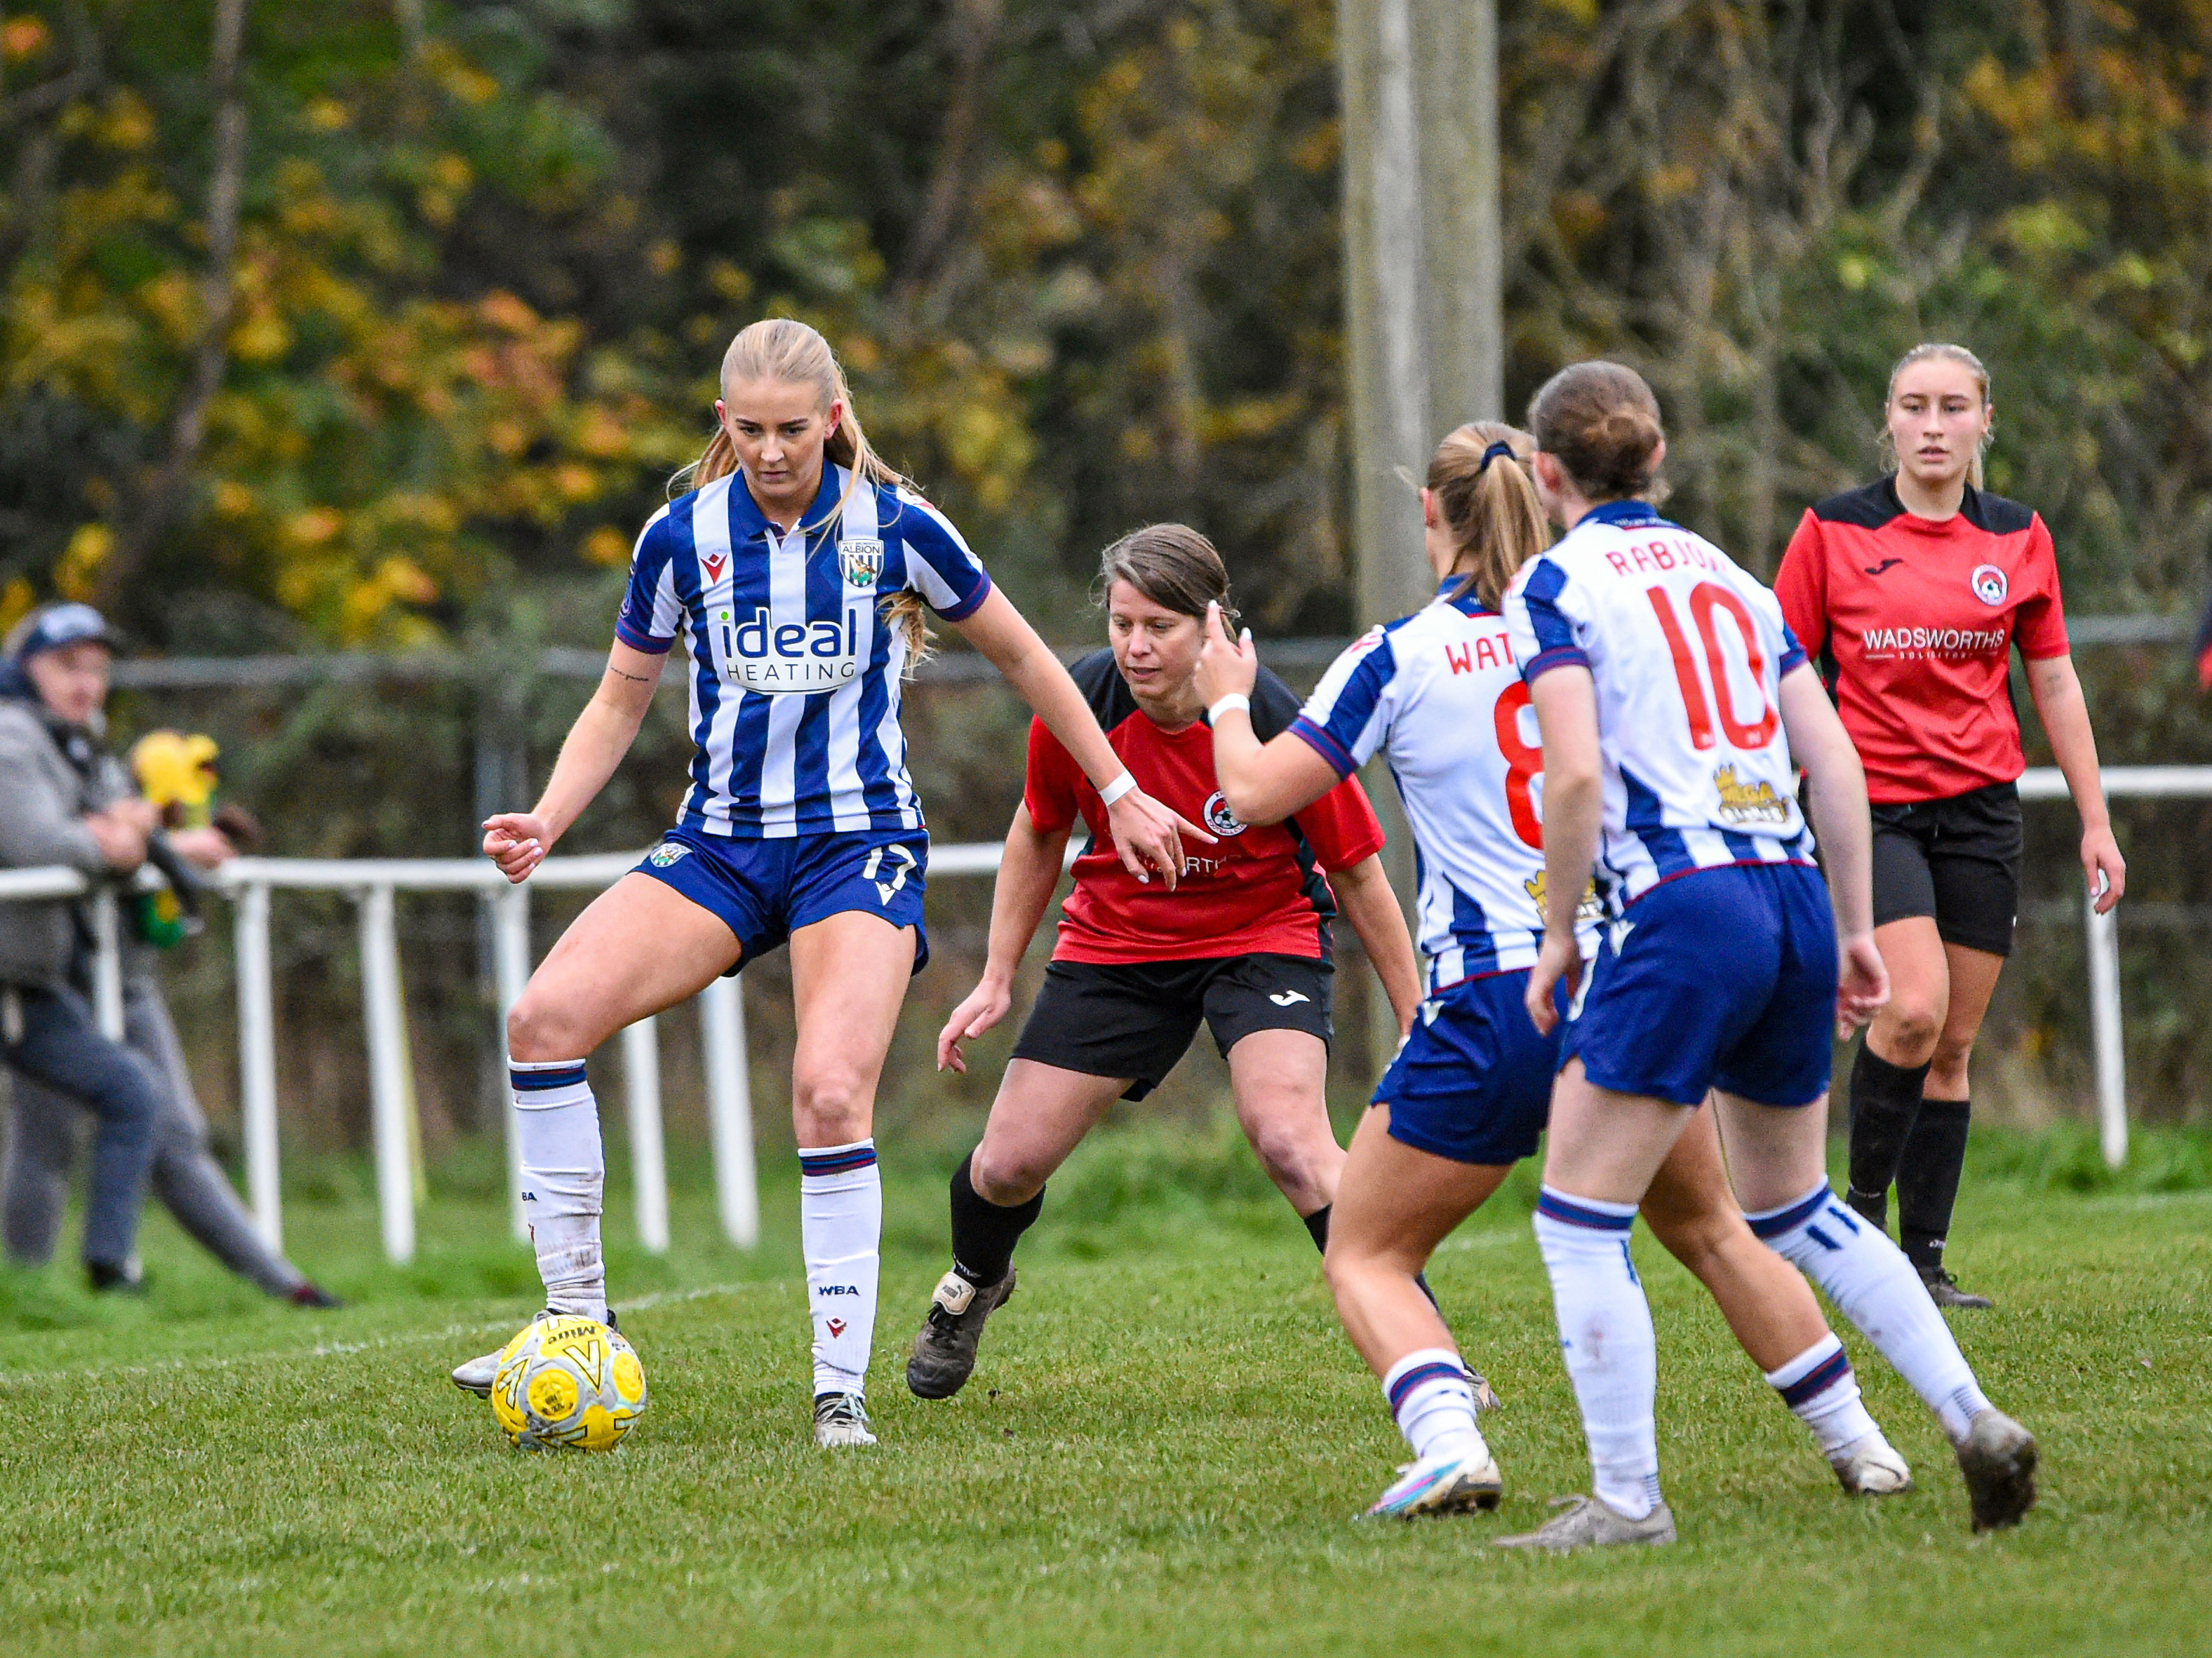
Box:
[792,911,916,1445]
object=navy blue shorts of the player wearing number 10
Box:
[1560,864,1838,1105]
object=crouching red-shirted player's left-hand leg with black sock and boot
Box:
[907,1059,1130,1399]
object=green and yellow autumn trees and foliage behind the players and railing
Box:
[0,0,2212,1140]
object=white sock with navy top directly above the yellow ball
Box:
[509,1059,606,1320]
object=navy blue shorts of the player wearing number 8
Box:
[1376,969,1566,1163]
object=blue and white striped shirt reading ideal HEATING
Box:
[615,466,991,840]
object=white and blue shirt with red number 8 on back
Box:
[1289,575,1597,995]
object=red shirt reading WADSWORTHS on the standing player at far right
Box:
[1774,478,2066,802]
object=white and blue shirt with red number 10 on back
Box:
[1504,502,1811,913]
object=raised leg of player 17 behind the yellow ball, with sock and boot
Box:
[453,871,737,1395]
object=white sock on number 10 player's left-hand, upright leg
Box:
[1535,1185,1659,1518]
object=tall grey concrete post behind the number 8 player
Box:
[1336,0,1504,1055]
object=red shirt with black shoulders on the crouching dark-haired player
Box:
[1022,650,1383,964]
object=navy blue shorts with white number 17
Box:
[637,825,929,973]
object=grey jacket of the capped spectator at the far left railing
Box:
[0,663,108,986]
